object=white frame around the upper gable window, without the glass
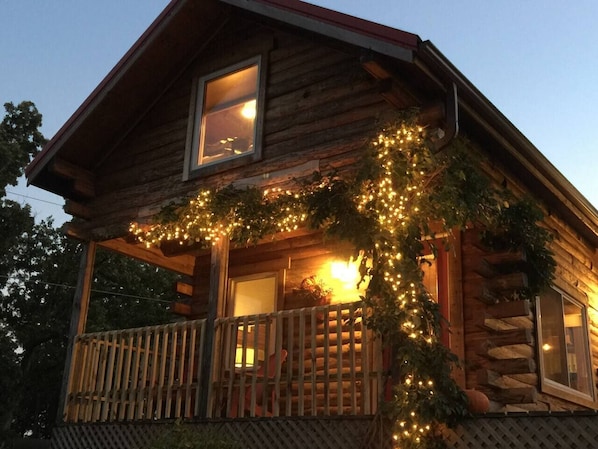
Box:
[183,55,265,181]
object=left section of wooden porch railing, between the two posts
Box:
[65,320,205,422]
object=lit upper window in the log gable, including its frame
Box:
[189,57,260,175]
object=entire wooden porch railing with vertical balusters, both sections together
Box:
[64,302,383,423]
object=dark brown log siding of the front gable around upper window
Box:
[67,14,398,239]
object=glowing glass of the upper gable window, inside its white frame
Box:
[197,64,258,165]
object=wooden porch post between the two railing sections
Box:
[199,237,230,418]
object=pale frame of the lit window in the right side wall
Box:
[536,286,596,407]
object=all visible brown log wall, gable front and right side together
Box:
[62,5,598,410]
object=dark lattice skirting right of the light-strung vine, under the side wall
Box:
[446,413,598,449]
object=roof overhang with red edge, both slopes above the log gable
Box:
[26,0,598,247]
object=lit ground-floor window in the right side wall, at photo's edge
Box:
[537,289,594,401]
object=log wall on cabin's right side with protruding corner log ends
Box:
[462,145,598,411]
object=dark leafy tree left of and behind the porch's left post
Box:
[0,221,175,437]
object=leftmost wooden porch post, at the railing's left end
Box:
[56,241,97,423]
